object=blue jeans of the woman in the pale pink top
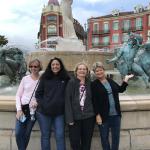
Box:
[15,119,35,150]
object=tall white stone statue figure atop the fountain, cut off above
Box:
[61,0,77,39]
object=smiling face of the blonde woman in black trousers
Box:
[76,64,88,78]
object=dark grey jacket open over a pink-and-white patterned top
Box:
[65,78,94,123]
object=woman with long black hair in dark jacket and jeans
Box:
[35,57,69,150]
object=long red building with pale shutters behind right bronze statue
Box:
[88,5,150,51]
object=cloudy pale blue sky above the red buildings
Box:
[0,0,150,50]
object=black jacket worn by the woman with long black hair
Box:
[35,78,67,116]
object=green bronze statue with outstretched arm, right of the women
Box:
[107,33,150,88]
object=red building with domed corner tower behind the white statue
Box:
[38,0,84,48]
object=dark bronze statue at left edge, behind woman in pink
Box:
[0,48,27,84]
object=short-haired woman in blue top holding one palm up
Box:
[92,62,133,150]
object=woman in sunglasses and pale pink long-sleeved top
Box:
[15,59,42,150]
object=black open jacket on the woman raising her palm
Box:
[92,78,128,122]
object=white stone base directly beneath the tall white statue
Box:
[56,38,85,51]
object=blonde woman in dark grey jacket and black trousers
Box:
[65,63,95,150]
